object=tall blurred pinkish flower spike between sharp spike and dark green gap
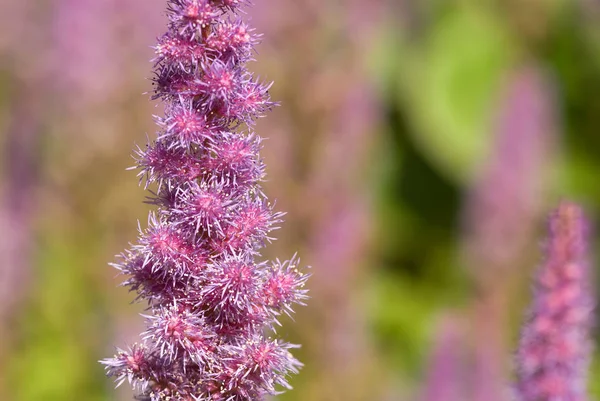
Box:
[307,83,377,400]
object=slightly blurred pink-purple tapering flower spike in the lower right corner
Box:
[516,202,593,401]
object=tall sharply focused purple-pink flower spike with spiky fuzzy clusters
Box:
[103,0,307,401]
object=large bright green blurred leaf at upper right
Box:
[396,6,515,180]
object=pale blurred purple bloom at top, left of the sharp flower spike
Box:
[53,0,164,112]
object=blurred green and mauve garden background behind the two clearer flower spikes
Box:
[0,0,600,401]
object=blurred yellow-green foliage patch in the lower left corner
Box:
[8,229,107,401]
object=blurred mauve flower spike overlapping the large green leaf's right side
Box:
[465,66,557,283]
